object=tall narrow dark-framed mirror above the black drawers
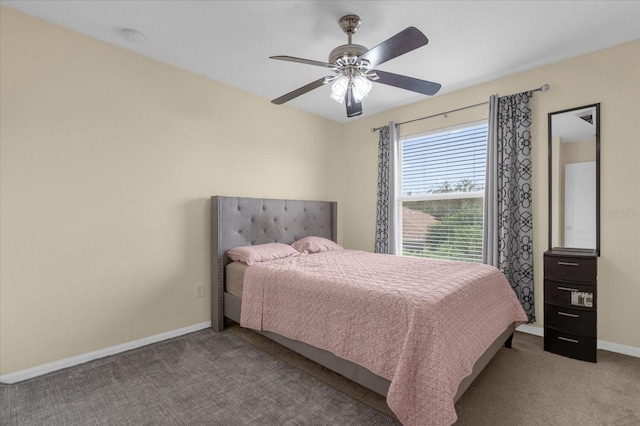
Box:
[549,103,600,255]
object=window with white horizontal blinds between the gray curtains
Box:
[396,121,487,262]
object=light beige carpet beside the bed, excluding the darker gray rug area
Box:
[229,324,640,426]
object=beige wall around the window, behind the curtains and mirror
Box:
[337,41,640,348]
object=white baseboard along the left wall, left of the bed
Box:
[0,321,211,384]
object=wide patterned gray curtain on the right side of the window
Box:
[483,92,535,322]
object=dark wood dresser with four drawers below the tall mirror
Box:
[544,248,598,362]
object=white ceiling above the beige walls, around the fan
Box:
[0,0,640,122]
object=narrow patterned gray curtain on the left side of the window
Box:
[375,121,396,254]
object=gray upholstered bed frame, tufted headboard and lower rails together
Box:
[211,196,515,401]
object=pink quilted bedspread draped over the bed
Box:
[241,250,527,426]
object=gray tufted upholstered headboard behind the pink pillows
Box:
[211,196,338,331]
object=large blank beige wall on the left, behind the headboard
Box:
[0,7,340,374]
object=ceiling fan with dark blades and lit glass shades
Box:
[270,15,441,117]
